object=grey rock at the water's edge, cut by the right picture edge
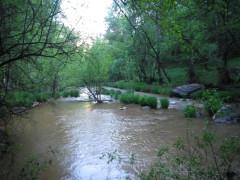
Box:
[212,105,240,123]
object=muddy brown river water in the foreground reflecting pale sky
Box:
[4,100,240,180]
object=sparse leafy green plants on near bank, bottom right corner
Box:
[140,130,240,180]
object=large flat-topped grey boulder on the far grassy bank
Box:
[170,83,204,97]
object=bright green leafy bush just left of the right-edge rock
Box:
[202,90,223,116]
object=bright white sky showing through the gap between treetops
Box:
[61,0,112,41]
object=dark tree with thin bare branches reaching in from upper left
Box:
[0,0,76,68]
